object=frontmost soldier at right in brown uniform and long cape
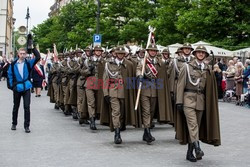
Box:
[176,46,220,162]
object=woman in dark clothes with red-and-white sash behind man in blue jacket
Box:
[31,61,45,97]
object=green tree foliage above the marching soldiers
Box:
[32,0,250,51]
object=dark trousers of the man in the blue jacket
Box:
[12,89,30,128]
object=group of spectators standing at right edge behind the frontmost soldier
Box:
[214,57,250,107]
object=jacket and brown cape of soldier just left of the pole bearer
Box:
[100,59,139,130]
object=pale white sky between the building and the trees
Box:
[14,0,54,30]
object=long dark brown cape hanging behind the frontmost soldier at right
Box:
[176,60,221,146]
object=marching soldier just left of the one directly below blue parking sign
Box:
[77,47,91,125]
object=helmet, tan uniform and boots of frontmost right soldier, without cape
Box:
[176,46,221,162]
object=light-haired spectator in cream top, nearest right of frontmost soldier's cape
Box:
[224,60,235,90]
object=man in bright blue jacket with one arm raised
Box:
[8,43,40,133]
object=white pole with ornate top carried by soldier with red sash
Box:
[135,26,155,111]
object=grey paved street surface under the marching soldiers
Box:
[0,81,250,167]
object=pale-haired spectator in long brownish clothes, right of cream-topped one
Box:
[234,62,244,105]
